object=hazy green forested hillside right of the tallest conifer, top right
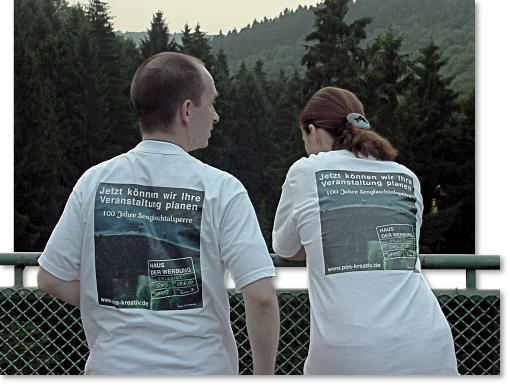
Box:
[346,0,475,94]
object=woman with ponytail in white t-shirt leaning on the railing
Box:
[273,87,458,374]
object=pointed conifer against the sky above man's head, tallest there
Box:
[140,11,178,59]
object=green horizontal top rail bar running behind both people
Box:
[0,252,500,270]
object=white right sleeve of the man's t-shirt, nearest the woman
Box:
[219,191,275,290]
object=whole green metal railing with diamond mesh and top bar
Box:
[0,253,500,374]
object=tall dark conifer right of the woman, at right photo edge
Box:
[391,41,475,253]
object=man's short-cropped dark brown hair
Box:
[130,52,205,133]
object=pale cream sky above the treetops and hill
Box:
[69,0,322,35]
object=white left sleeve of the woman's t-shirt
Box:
[273,168,301,257]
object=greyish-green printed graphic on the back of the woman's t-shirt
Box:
[315,170,417,274]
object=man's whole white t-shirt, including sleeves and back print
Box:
[39,140,274,374]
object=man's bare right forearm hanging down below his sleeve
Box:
[241,277,280,374]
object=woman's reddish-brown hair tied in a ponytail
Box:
[299,87,398,160]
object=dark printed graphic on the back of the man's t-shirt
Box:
[94,183,204,310]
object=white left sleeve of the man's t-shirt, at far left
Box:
[39,183,85,281]
